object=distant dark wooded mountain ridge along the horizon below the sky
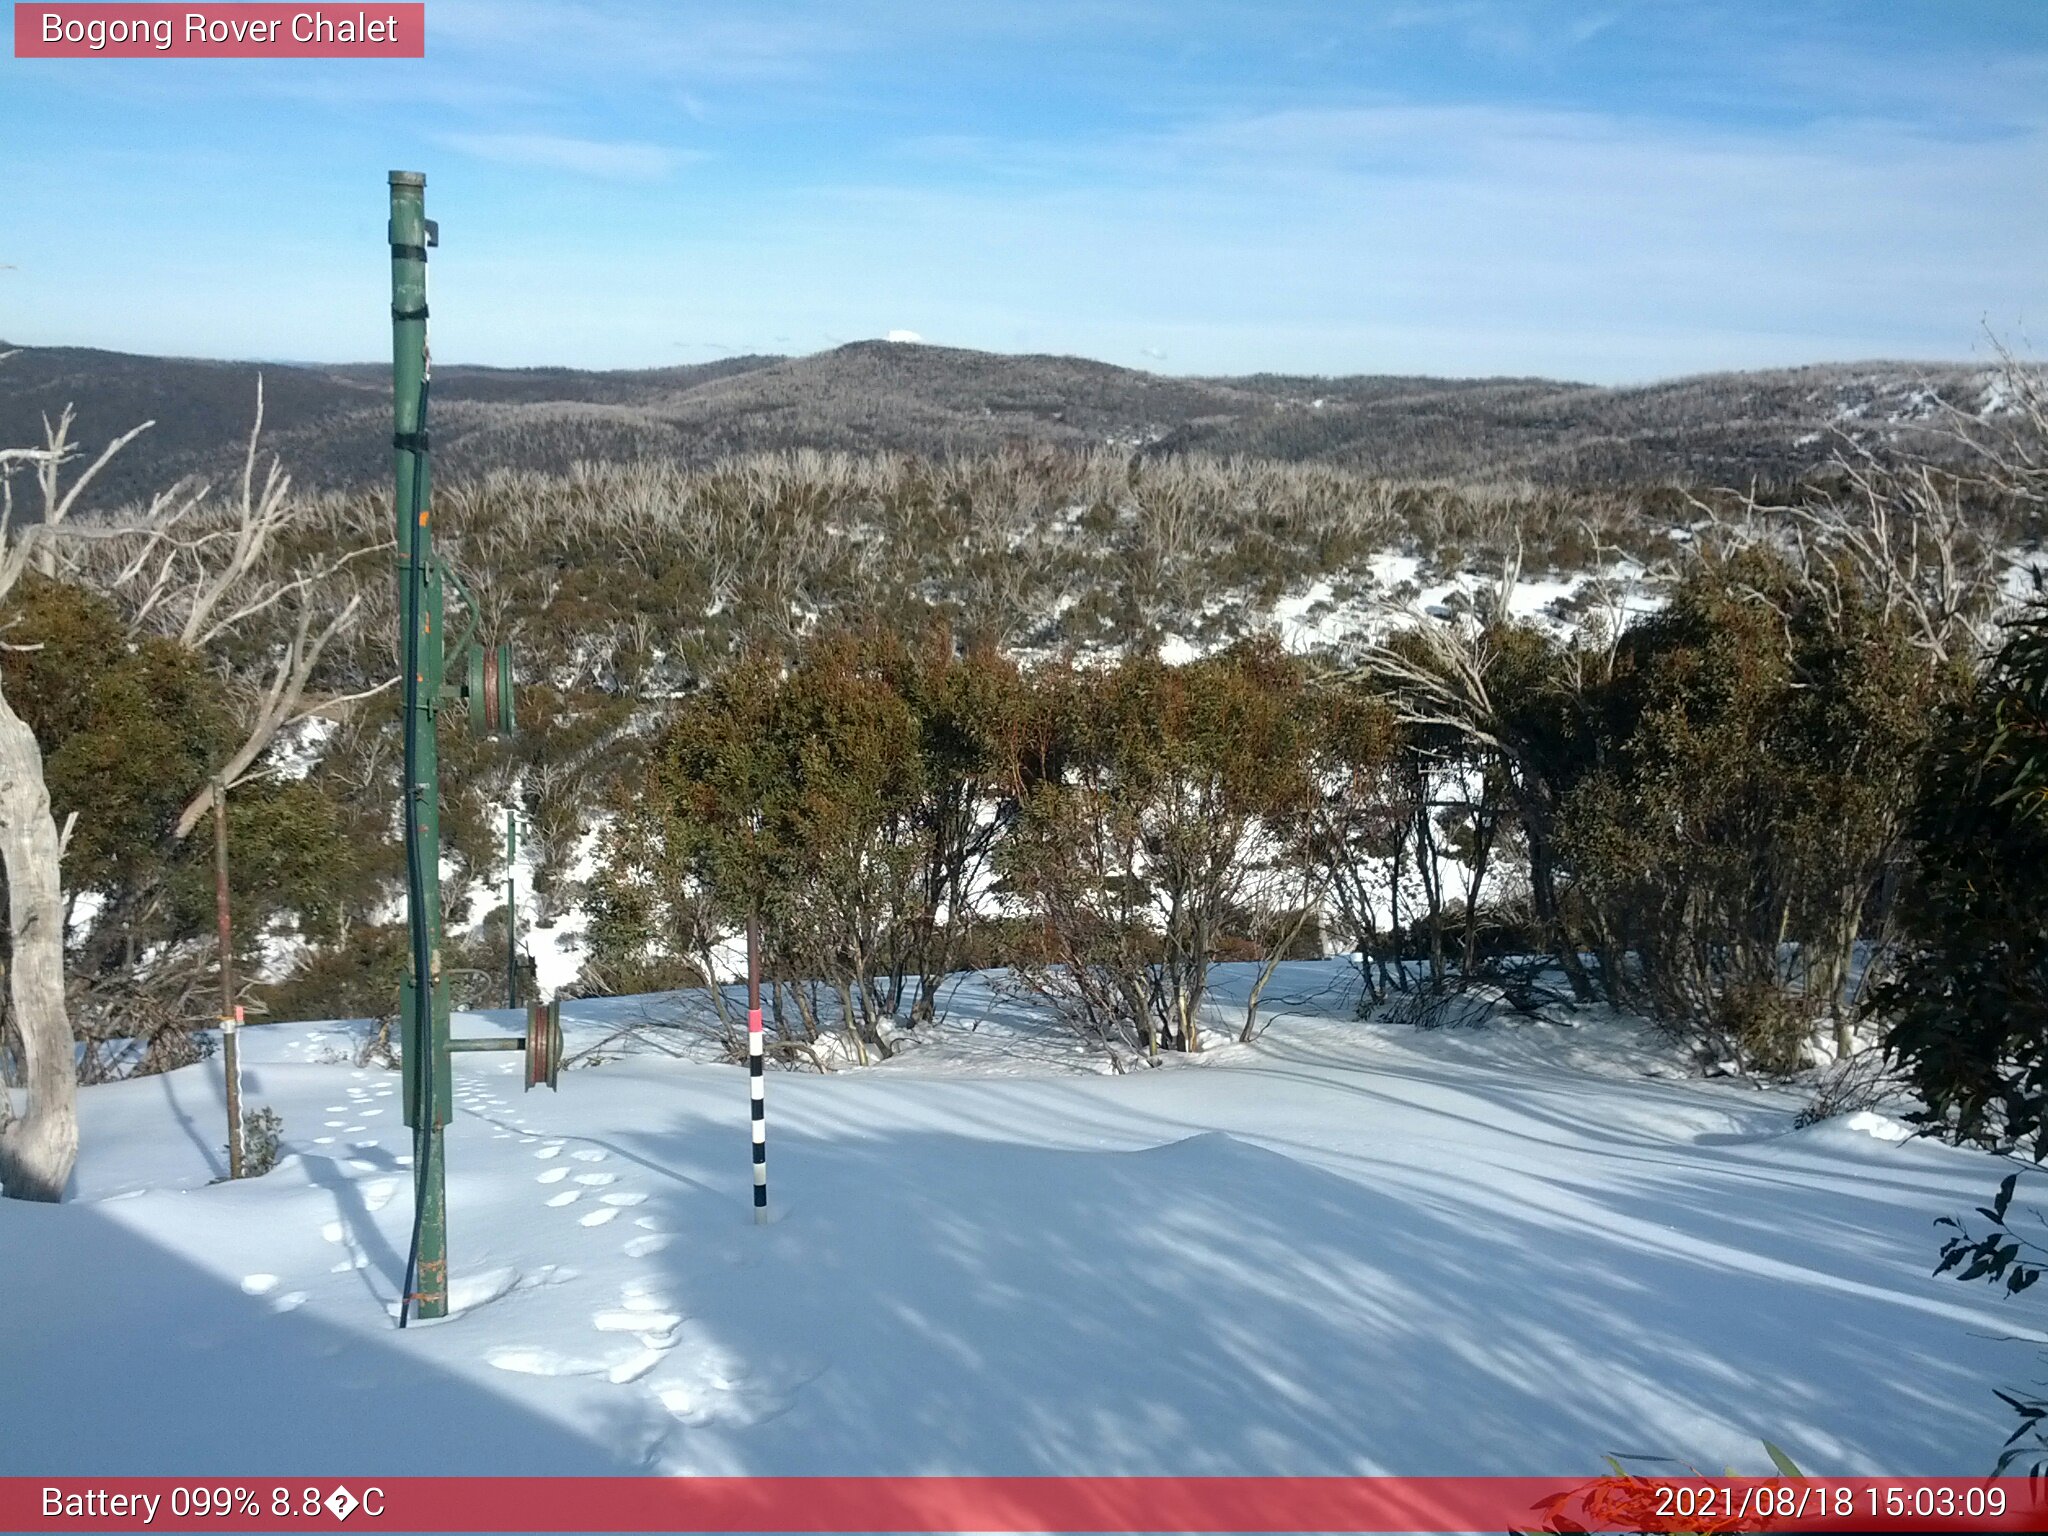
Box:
[0,342,1993,500]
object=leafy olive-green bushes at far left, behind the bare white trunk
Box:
[0,575,360,1081]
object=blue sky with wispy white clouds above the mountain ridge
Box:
[0,0,2048,383]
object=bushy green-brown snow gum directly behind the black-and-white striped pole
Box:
[590,627,1018,1059]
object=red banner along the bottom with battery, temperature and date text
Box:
[0,1477,2048,1532]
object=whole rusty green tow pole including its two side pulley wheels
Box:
[389,170,561,1327]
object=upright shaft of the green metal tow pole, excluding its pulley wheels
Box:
[389,170,453,1321]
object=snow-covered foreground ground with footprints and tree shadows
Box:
[0,963,2038,1475]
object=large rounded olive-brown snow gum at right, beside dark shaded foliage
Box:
[1561,549,1956,1071]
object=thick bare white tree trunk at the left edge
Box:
[0,694,78,1200]
